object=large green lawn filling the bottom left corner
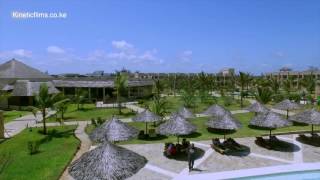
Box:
[0,126,80,180]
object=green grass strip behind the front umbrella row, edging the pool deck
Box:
[86,113,311,144]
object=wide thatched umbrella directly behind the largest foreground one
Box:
[90,117,139,142]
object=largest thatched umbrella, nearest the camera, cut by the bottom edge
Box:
[68,142,147,180]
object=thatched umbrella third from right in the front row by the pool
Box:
[206,114,241,139]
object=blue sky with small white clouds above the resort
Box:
[0,0,320,74]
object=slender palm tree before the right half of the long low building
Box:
[114,72,128,114]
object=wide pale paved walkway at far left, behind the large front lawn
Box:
[4,111,56,138]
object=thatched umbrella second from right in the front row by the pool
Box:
[250,111,291,137]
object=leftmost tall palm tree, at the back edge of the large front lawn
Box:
[34,83,58,134]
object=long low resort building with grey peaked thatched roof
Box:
[0,59,153,108]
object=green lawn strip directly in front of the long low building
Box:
[48,104,135,122]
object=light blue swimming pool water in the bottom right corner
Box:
[237,170,320,180]
